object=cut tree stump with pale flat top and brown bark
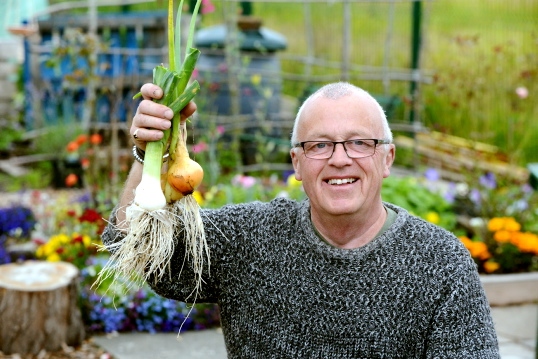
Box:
[0,261,85,355]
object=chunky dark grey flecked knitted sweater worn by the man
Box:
[103,198,499,359]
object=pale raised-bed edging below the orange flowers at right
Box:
[480,272,538,306]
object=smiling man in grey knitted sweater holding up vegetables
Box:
[103,83,499,359]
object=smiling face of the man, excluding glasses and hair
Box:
[291,93,395,217]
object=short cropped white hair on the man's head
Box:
[291,82,392,147]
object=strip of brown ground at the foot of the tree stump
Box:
[0,339,114,359]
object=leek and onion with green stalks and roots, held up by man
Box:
[94,0,209,302]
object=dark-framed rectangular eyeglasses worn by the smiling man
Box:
[293,139,390,160]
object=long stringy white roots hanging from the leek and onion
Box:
[94,195,210,302]
